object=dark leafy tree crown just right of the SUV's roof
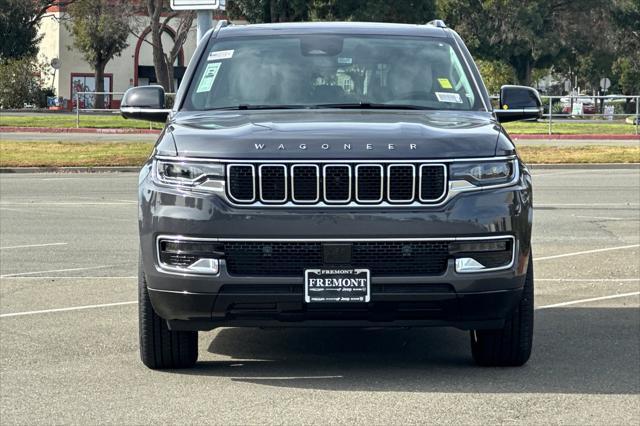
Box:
[438,0,606,85]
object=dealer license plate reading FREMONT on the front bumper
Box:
[304,269,371,303]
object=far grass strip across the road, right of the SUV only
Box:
[504,121,635,135]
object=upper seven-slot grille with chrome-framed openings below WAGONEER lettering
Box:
[227,163,447,206]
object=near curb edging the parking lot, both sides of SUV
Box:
[0,163,640,174]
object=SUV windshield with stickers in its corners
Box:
[183,34,482,111]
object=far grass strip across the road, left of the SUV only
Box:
[0,114,163,129]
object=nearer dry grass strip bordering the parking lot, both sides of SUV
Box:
[0,140,640,167]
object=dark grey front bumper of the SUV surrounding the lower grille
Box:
[139,161,532,330]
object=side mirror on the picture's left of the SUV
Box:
[120,86,171,123]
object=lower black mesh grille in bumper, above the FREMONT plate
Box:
[224,241,449,276]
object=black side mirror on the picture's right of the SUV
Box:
[495,86,542,123]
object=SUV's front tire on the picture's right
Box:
[471,257,533,367]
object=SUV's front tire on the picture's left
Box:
[138,260,198,370]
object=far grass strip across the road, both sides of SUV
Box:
[0,114,635,135]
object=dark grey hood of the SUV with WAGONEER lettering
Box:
[167,109,500,160]
